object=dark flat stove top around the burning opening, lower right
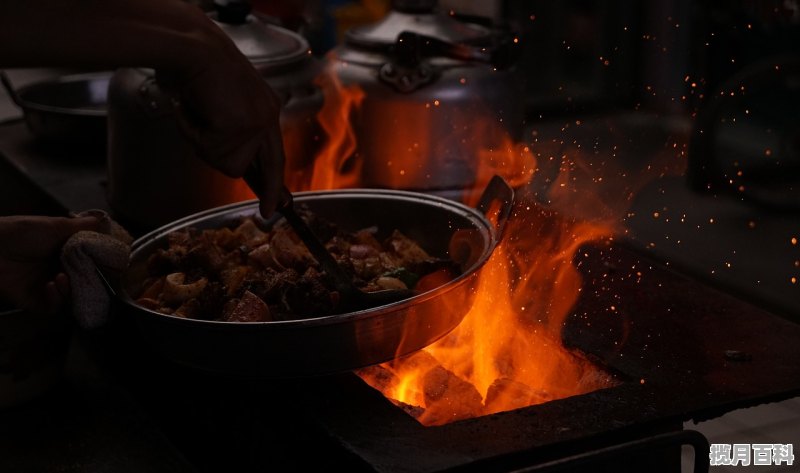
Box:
[286,242,800,471]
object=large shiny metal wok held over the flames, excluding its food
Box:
[120,177,513,378]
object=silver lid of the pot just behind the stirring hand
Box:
[209,0,310,70]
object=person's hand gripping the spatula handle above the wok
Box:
[157,24,284,217]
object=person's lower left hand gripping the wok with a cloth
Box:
[0,216,99,314]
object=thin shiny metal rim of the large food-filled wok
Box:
[120,188,499,330]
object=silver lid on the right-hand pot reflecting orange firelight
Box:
[346,8,491,48]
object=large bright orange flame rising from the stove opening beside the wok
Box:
[359,200,613,425]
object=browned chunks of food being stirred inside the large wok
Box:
[136,209,460,322]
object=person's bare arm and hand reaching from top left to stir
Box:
[0,0,284,214]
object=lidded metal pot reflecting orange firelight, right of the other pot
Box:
[328,0,524,195]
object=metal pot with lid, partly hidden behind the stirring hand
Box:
[108,2,322,229]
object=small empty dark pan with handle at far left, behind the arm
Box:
[0,71,111,148]
